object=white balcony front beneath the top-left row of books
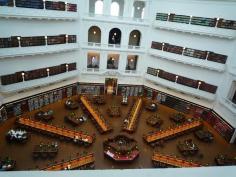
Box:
[0,2,79,20]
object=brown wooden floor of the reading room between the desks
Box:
[0,96,236,170]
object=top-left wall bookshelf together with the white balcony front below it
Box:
[0,0,78,20]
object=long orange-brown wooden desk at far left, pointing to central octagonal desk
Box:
[18,118,94,144]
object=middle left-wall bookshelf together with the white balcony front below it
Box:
[0,34,79,58]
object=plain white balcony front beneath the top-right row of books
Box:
[153,20,236,39]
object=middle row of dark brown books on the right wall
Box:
[151,41,228,64]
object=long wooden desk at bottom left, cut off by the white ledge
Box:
[42,153,95,171]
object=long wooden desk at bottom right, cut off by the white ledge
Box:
[152,153,201,167]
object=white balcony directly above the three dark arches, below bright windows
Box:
[83,13,149,26]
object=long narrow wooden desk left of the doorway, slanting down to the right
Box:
[80,96,112,133]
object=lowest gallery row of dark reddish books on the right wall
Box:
[147,67,217,93]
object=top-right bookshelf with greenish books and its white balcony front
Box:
[153,12,236,39]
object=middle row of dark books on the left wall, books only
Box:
[0,34,76,48]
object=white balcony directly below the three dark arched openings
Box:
[82,42,145,53]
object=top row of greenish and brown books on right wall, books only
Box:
[156,13,236,30]
